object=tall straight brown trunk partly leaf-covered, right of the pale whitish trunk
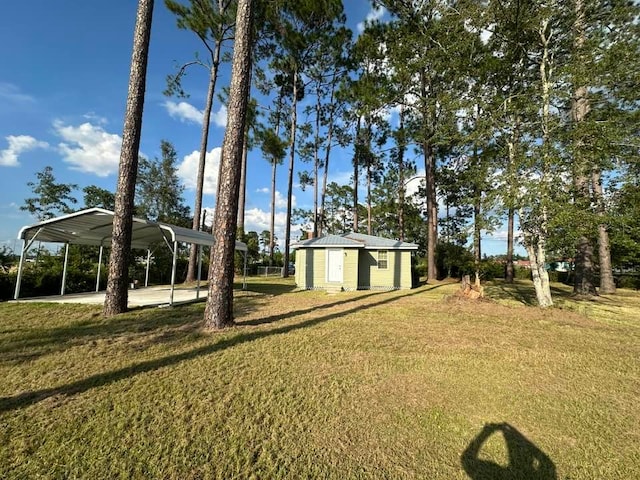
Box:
[571,0,596,295]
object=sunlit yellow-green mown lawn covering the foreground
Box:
[0,279,640,479]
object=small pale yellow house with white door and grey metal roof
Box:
[292,233,418,290]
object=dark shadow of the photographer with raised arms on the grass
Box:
[461,423,558,480]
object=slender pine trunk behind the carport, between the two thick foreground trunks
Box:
[185,42,221,282]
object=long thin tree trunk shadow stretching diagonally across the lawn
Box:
[0,291,430,413]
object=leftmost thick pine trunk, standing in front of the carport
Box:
[102,0,153,316]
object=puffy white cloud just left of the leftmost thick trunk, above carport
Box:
[53,120,122,177]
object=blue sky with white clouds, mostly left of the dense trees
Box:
[0,0,516,254]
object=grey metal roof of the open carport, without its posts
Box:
[18,208,247,252]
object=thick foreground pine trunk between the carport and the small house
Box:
[204,0,254,329]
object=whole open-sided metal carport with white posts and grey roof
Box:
[14,208,247,305]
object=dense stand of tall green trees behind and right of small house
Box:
[238,0,640,306]
